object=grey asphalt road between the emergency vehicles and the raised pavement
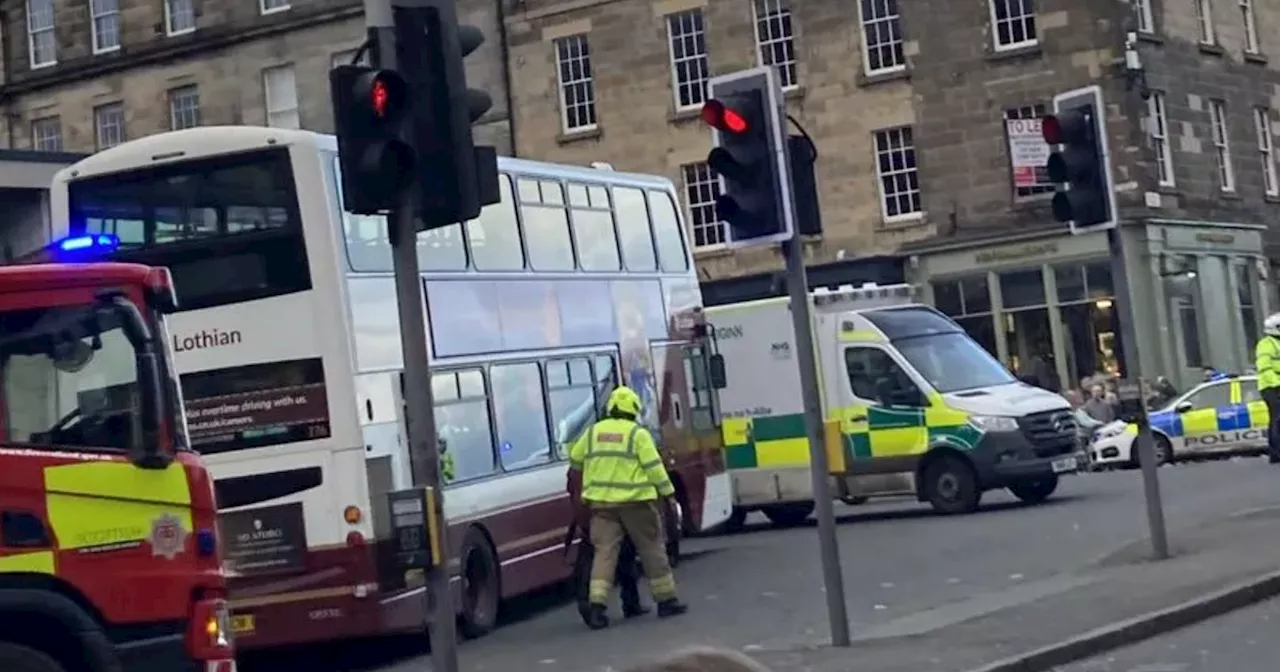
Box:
[243,458,1280,672]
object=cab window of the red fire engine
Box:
[0,305,141,451]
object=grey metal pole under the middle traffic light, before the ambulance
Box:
[782,234,850,646]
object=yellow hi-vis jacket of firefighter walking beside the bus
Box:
[568,419,676,504]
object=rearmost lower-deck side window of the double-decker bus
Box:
[431,369,498,483]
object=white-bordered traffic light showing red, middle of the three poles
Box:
[701,68,792,247]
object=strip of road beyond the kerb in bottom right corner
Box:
[1056,599,1280,672]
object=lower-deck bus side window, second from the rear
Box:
[489,362,552,471]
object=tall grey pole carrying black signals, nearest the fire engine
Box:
[365,0,458,672]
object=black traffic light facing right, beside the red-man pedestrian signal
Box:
[392,0,499,229]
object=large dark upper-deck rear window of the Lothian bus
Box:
[68,147,311,310]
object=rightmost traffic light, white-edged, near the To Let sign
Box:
[1041,87,1116,232]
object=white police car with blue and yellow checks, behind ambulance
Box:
[1089,375,1268,467]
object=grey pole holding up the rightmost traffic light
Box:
[1107,227,1169,561]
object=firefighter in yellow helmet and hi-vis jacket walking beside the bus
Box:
[568,387,689,630]
